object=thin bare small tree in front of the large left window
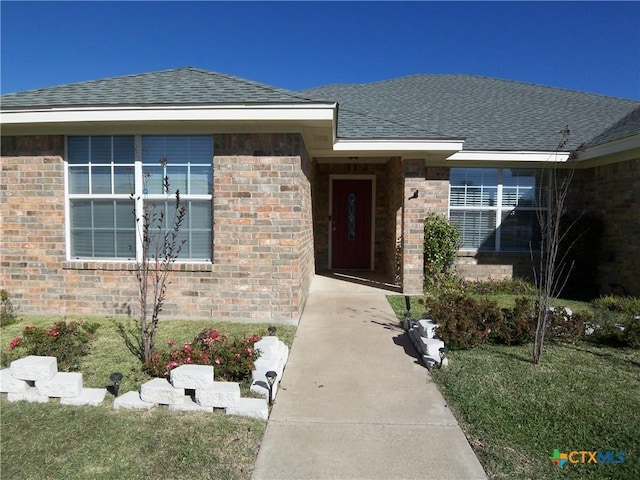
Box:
[119,157,187,363]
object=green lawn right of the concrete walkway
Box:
[389,295,640,479]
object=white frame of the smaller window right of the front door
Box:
[447,166,548,253]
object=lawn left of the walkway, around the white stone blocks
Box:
[0,316,295,480]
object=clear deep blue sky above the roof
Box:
[0,0,640,100]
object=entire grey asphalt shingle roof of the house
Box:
[0,67,640,151]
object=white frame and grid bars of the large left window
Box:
[63,134,215,264]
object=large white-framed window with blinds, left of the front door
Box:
[65,136,213,260]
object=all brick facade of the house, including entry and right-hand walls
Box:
[0,134,640,321]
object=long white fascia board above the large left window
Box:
[0,104,336,125]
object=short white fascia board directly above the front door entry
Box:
[333,139,464,153]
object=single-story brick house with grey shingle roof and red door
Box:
[0,68,640,322]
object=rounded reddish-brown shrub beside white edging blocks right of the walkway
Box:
[431,293,501,349]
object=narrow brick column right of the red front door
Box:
[402,159,427,295]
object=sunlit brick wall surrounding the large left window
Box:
[0,134,313,321]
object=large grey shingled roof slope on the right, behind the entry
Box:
[299,75,640,150]
